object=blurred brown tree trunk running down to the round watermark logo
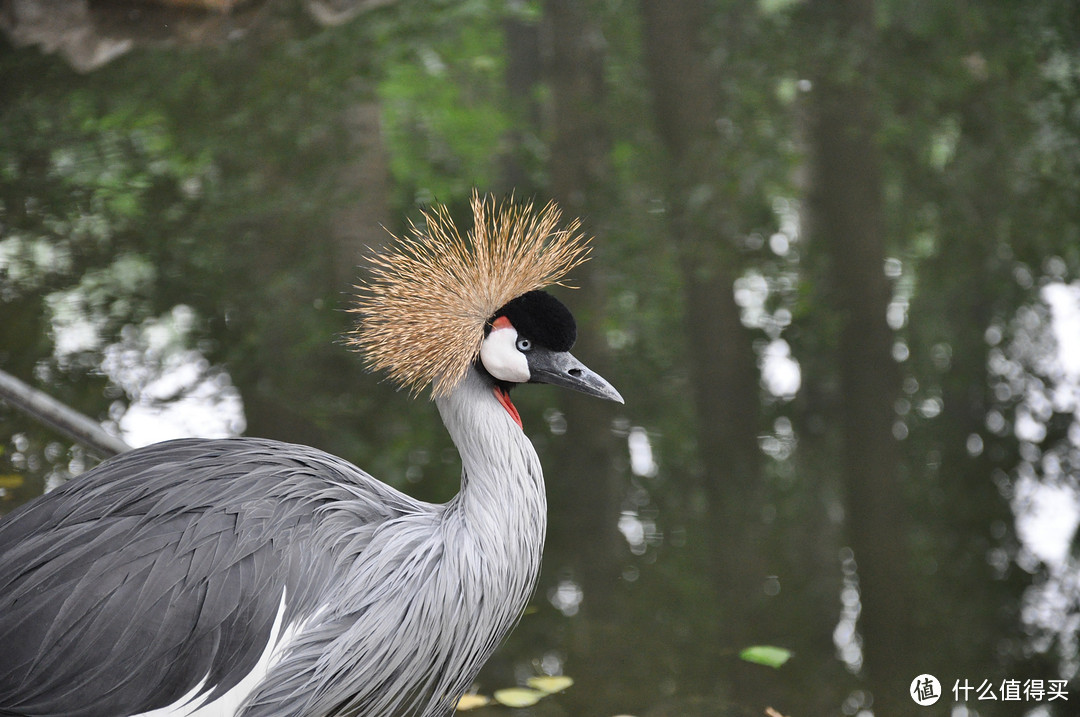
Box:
[809,0,920,715]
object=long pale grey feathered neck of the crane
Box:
[436,369,548,587]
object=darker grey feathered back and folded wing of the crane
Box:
[0,438,427,717]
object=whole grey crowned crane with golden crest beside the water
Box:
[0,194,622,717]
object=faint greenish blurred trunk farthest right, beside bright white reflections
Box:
[910,19,1041,681]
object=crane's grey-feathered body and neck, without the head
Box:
[0,369,545,717]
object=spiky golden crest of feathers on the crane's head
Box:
[348,192,590,396]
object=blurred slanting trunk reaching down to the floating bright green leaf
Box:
[640,0,769,702]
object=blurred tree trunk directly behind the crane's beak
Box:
[541,0,626,714]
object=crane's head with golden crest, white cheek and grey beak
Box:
[348,193,622,414]
